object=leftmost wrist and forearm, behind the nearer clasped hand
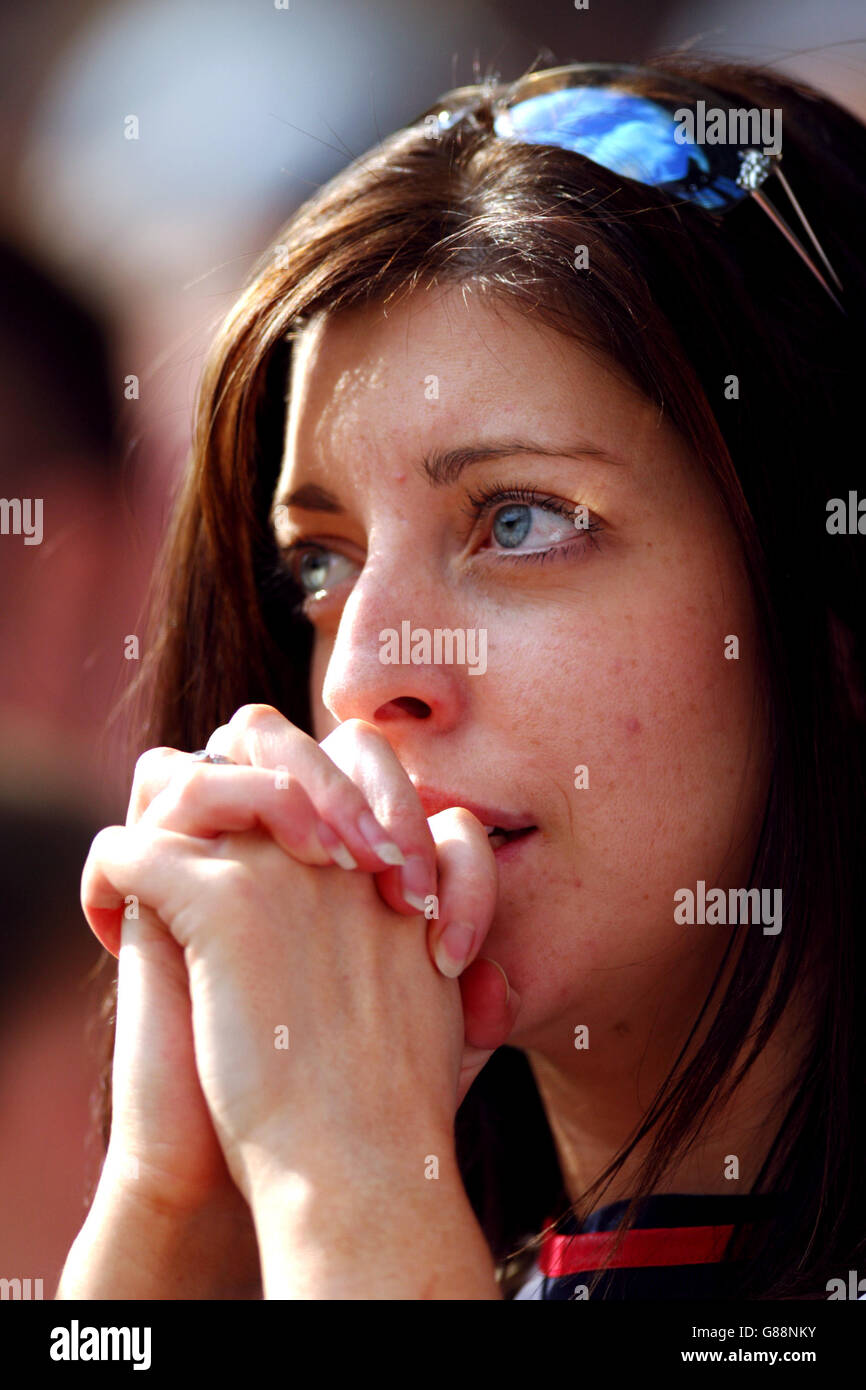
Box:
[57,767,261,1298]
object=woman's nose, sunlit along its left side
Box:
[314,556,474,734]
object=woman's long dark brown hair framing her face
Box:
[97,48,866,1297]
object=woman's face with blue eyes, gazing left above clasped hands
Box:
[275,288,766,1059]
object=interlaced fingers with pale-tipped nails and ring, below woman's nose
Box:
[125,705,520,1104]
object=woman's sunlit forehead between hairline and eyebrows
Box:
[281,285,657,484]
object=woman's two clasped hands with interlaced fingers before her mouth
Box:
[71,705,518,1297]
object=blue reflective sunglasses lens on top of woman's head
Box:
[493,86,745,210]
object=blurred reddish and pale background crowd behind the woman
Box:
[0,0,866,1298]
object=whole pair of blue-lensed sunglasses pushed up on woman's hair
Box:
[411,63,845,313]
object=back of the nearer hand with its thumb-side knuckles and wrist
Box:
[82,800,505,1297]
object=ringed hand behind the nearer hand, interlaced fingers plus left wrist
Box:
[64,706,518,1297]
